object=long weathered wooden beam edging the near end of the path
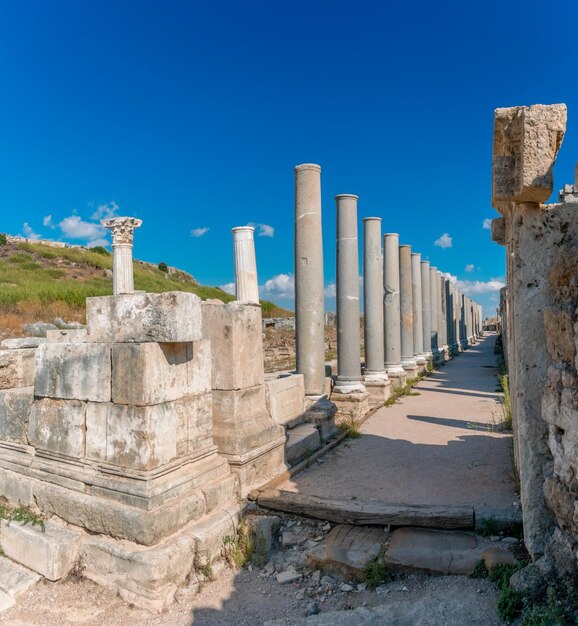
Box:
[257,489,474,528]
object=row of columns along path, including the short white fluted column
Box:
[228,163,482,397]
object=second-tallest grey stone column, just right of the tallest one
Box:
[335,194,365,393]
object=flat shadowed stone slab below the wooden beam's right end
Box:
[385,528,482,576]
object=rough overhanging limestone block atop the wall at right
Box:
[492,104,566,206]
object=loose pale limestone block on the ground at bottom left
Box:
[0,521,80,581]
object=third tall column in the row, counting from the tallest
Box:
[363,217,387,380]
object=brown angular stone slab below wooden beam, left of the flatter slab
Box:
[307,524,389,581]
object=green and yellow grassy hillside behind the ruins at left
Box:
[0,239,289,336]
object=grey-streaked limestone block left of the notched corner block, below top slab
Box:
[34,343,111,402]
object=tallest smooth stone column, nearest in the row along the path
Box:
[295,163,325,396]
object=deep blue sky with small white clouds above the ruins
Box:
[0,0,578,313]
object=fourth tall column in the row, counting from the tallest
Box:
[383,233,405,378]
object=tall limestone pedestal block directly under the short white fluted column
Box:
[198,302,265,389]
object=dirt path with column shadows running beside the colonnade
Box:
[280,334,519,520]
